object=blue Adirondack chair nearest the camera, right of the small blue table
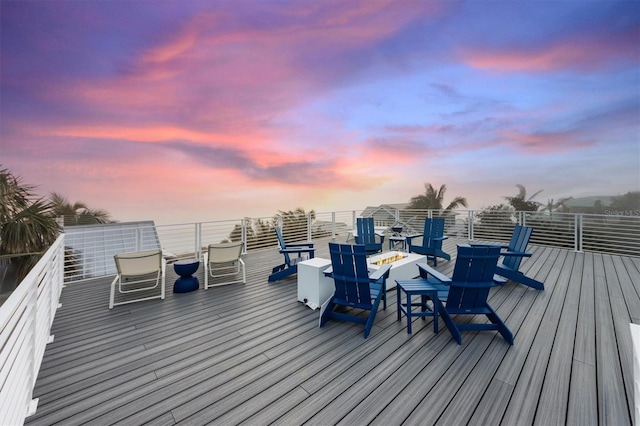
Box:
[418,245,513,345]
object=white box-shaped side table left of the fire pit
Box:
[298,257,335,309]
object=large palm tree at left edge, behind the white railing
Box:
[0,169,60,282]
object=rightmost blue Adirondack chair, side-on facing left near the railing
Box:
[496,225,544,290]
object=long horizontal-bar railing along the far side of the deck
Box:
[57,208,640,281]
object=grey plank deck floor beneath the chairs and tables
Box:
[27,240,640,425]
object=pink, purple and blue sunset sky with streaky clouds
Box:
[0,0,640,224]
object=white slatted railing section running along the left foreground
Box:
[0,235,64,425]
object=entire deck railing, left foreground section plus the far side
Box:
[0,208,640,424]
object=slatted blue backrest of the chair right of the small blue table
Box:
[447,245,500,308]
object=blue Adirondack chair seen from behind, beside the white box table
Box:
[320,243,391,338]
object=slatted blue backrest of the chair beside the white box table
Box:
[329,243,373,309]
